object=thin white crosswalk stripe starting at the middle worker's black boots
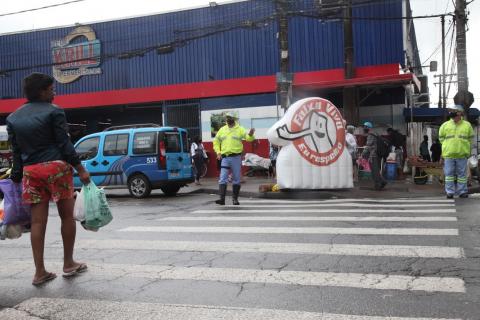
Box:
[226,201,455,208]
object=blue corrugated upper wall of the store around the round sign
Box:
[0,0,404,99]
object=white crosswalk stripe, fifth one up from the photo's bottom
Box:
[157,216,457,222]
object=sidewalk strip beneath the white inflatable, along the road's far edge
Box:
[107,177,454,199]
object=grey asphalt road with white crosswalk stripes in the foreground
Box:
[0,194,480,320]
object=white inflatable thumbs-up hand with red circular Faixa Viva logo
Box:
[267,98,353,189]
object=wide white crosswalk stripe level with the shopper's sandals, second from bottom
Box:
[0,261,465,293]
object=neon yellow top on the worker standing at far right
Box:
[438,119,473,159]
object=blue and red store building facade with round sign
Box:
[0,0,421,170]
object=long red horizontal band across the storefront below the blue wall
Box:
[0,64,419,114]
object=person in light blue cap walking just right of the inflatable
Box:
[362,121,387,190]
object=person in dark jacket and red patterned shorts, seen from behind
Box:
[7,73,90,285]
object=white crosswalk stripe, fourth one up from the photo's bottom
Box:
[119,226,458,236]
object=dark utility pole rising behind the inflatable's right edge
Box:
[342,0,359,124]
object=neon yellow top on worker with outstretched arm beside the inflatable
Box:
[213,123,255,155]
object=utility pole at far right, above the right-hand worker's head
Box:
[454,0,474,115]
